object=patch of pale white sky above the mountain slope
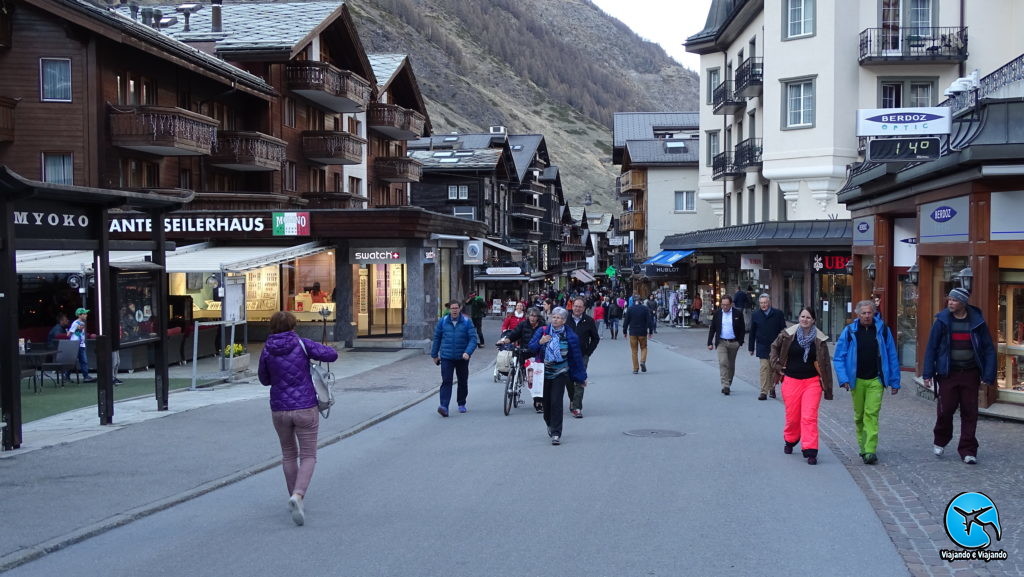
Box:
[591,0,711,70]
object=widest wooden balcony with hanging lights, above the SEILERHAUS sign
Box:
[110,107,220,157]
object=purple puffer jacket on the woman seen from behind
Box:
[259,331,338,411]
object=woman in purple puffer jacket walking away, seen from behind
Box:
[259,312,338,525]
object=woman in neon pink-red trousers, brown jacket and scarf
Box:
[769,306,833,465]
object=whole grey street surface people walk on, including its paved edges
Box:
[0,320,1022,576]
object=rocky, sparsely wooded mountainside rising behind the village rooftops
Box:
[348,0,702,212]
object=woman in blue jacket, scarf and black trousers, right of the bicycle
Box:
[527,306,587,445]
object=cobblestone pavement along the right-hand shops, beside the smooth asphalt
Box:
[653,326,1024,577]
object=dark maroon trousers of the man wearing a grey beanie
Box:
[932,369,981,458]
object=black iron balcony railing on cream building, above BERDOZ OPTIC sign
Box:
[859,27,968,65]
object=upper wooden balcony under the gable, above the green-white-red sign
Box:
[285,60,371,113]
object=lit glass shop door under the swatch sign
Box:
[358,264,406,336]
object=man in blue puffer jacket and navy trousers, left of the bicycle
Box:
[430,300,476,417]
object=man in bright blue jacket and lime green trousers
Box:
[833,300,899,465]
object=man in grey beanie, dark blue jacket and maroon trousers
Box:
[921,287,995,465]
